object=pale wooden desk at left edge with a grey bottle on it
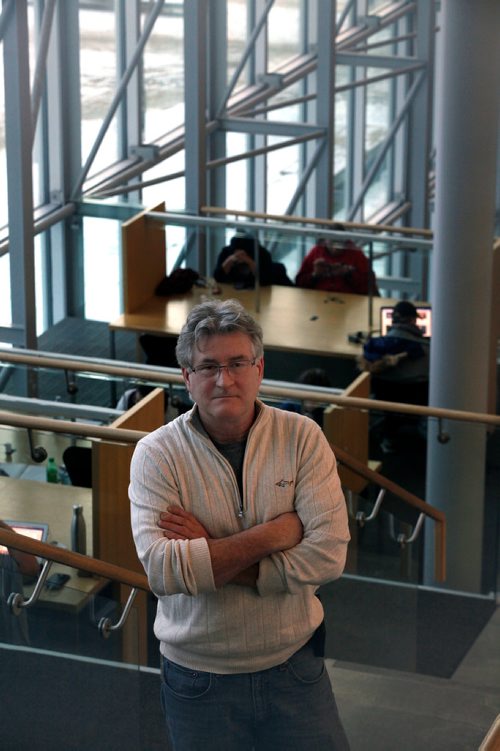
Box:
[0,476,106,611]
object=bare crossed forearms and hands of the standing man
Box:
[158,506,303,588]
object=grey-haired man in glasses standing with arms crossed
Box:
[130,300,349,751]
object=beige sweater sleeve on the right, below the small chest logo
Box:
[257,426,350,596]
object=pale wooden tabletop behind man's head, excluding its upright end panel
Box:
[109,284,395,359]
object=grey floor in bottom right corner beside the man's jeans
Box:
[327,608,500,751]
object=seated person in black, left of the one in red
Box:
[214,235,292,289]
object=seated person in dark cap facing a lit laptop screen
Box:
[358,300,430,449]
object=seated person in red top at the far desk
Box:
[295,224,378,295]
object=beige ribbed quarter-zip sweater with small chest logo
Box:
[129,401,349,673]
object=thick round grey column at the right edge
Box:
[425,0,500,592]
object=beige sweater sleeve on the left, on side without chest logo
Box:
[129,441,215,597]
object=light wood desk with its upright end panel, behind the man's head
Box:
[110,207,402,368]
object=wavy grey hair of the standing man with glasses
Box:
[175,300,264,368]
